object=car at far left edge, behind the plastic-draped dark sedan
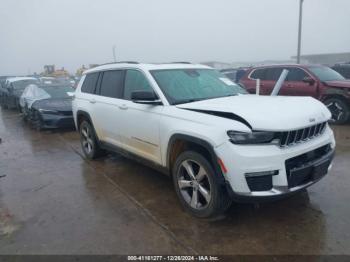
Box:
[0,77,38,110]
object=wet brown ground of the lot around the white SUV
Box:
[0,108,350,254]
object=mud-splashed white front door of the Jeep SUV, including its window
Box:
[118,69,163,164]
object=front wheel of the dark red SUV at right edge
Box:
[324,97,350,125]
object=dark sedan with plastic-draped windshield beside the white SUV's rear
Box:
[20,85,74,130]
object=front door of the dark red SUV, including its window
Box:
[280,67,317,97]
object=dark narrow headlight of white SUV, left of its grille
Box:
[227,130,275,144]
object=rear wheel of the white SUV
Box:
[79,120,105,160]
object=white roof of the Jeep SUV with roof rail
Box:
[83,63,212,75]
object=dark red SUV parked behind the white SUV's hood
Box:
[240,65,350,124]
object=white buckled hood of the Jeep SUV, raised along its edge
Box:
[177,95,331,131]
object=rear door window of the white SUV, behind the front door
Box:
[100,70,124,98]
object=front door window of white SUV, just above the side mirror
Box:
[123,70,153,100]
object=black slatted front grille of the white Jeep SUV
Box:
[280,122,327,147]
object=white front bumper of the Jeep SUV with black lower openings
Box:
[216,127,335,201]
